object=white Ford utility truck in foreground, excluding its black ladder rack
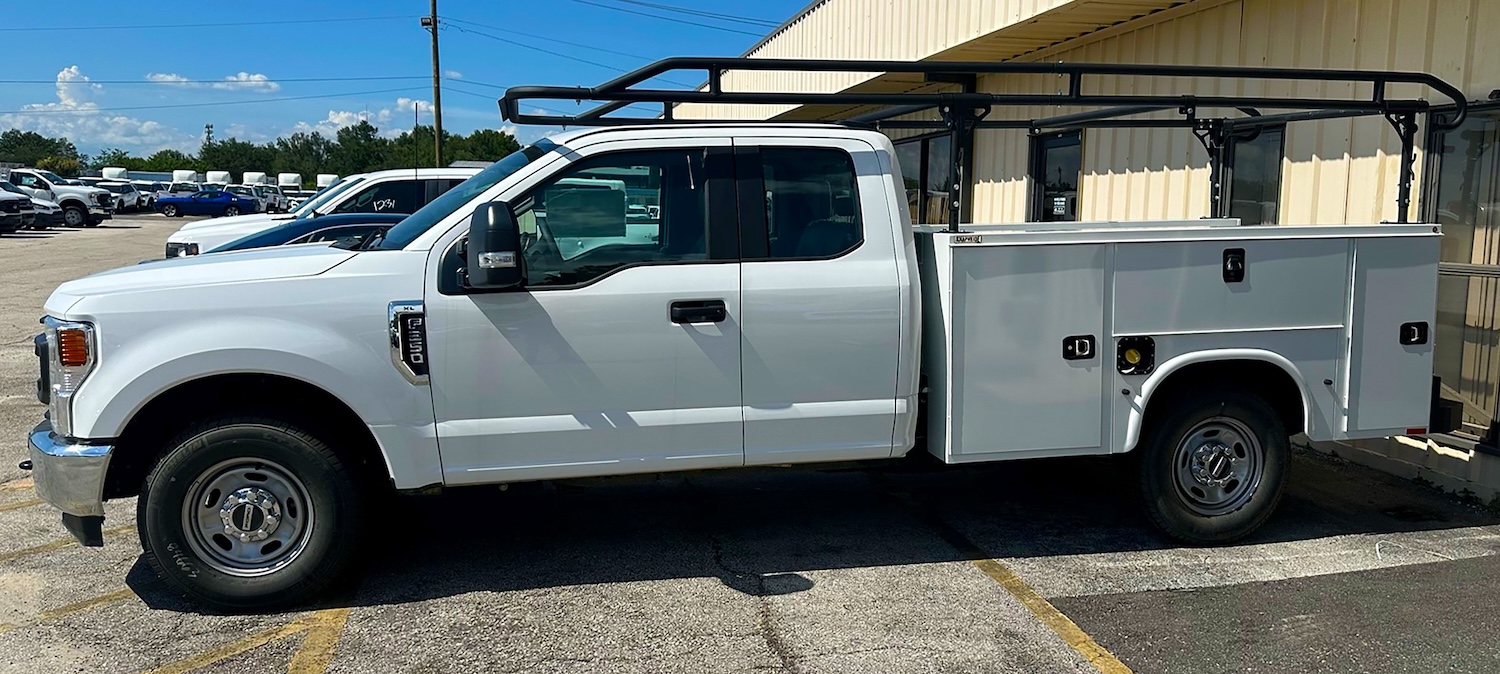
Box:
[17,60,1458,609]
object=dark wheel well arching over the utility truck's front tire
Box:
[104,374,392,498]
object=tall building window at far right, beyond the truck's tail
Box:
[1424,105,1500,450]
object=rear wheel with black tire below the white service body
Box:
[1137,390,1290,545]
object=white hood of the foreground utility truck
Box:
[47,246,357,309]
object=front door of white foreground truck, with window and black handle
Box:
[426,140,744,485]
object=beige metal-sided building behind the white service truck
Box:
[675,0,1500,494]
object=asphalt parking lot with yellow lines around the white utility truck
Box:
[0,215,1500,674]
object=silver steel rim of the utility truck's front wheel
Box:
[182,458,315,576]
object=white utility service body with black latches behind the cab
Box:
[917,221,1440,464]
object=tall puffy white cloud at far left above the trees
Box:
[0,66,197,153]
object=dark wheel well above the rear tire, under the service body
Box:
[1145,360,1307,435]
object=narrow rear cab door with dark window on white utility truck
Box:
[735,138,905,464]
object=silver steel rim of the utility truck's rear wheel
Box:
[1172,417,1266,516]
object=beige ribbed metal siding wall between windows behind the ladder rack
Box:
[974,0,1500,224]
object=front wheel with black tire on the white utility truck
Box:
[137,417,362,611]
